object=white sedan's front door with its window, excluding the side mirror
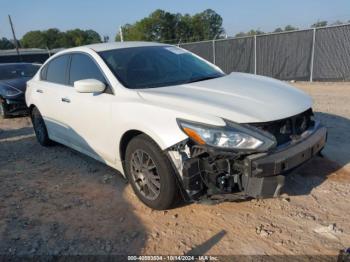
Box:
[66,53,115,162]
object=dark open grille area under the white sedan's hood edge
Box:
[251,108,314,146]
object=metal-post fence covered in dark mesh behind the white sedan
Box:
[180,24,350,81]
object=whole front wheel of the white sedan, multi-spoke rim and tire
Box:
[125,135,178,210]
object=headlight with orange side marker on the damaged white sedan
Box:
[178,119,275,150]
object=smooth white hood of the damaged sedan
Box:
[138,73,312,123]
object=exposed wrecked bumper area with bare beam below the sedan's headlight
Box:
[168,125,327,200]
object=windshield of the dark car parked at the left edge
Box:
[0,64,40,80]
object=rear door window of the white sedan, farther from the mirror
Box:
[46,55,69,85]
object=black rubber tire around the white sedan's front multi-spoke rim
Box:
[125,135,178,210]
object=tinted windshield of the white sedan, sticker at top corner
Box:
[99,46,224,89]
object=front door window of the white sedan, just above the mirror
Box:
[69,54,107,86]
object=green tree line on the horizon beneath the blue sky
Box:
[0,9,350,49]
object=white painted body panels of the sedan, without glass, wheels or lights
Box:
[26,42,312,173]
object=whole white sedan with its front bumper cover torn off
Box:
[26,42,327,209]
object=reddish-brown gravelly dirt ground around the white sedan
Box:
[0,83,350,255]
